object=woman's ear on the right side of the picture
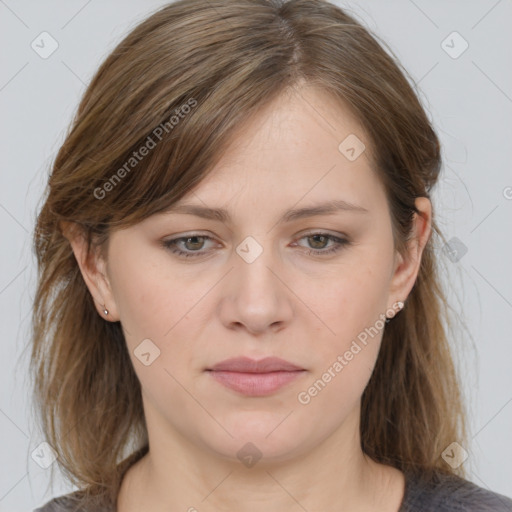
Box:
[389,197,432,308]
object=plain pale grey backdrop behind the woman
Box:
[0,0,512,512]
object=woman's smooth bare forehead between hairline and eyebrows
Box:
[178,88,384,215]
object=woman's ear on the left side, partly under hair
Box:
[60,222,119,322]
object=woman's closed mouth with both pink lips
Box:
[206,357,307,396]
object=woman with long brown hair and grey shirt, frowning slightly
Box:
[32,0,512,512]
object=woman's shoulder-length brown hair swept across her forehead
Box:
[30,0,467,503]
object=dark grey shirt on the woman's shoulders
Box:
[34,473,512,512]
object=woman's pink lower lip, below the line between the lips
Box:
[208,370,305,396]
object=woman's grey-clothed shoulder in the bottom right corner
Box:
[399,473,512,512]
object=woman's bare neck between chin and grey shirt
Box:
[118,408,404,512]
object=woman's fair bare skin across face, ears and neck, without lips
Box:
[64,87,431,512]
